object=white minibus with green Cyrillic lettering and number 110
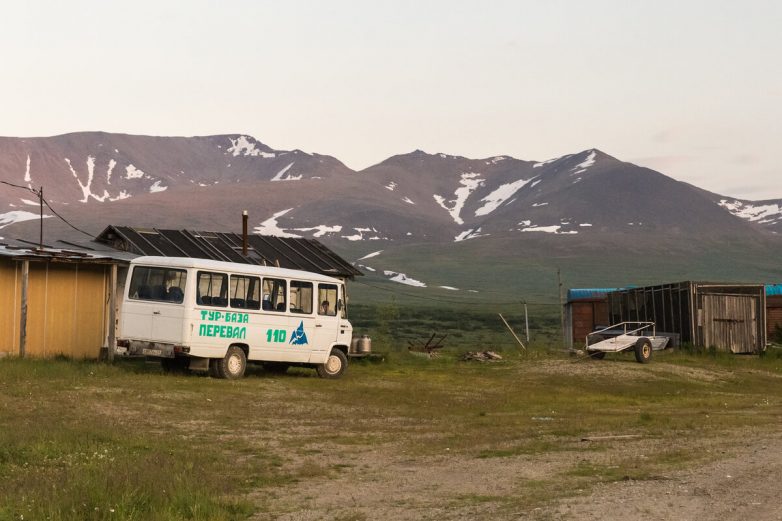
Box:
[117,257,353,379]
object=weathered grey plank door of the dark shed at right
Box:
[703,295,758,353]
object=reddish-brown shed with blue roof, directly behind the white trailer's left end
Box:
[564,288,616,349]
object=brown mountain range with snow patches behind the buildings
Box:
[0,132,782,296]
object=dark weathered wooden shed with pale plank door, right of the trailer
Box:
[608,281,767,353]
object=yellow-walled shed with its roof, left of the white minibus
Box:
[0,246,130,359]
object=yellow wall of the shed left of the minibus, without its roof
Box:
[0,259,110,358]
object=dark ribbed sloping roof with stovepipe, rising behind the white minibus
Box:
[95,226,363,278]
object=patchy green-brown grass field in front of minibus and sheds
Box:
[0,349,782,520]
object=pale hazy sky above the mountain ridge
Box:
[0,0,782,199]
